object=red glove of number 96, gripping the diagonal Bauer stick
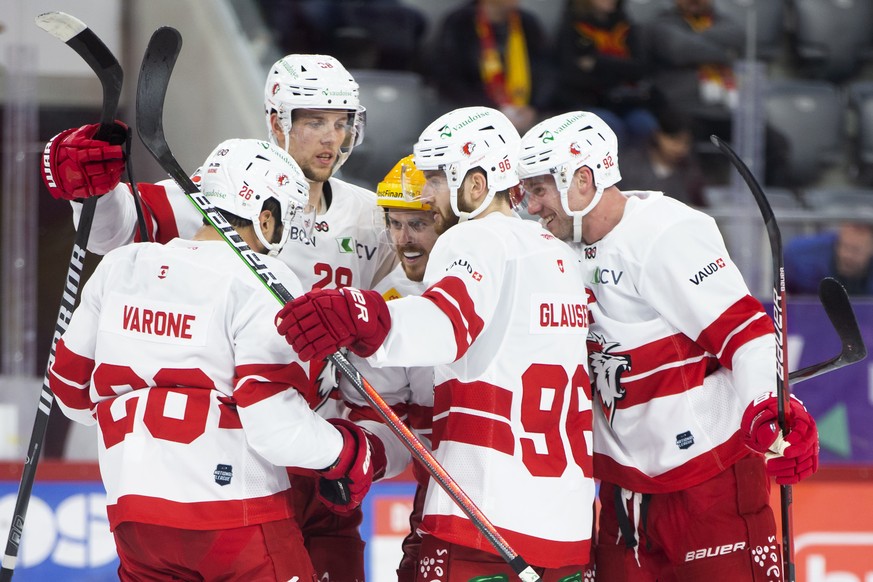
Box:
[276,287,391,361]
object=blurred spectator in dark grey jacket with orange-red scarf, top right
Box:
[646,0,791,186]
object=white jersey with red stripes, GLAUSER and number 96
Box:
[370,214,594,567]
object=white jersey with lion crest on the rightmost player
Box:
[580,192,776,493]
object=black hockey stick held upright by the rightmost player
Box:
[710,135,795,582]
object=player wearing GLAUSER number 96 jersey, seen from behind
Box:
[277,107,594,582]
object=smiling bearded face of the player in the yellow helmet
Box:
[387,208,439,281]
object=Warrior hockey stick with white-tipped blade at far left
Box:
[0,12,124,582]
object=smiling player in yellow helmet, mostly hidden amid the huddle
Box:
[340,155,439,582]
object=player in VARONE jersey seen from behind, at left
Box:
[49,140,372,581]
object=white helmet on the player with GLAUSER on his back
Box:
[413,107,521,222]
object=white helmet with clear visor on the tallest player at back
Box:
[264,54,366,172]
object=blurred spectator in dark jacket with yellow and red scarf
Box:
[431,0,551,132]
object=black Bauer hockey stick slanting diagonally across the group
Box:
[136,27,541,582]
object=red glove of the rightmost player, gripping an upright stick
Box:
[741,392,819,485]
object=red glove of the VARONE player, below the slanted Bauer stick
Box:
[316,418,385,515]
